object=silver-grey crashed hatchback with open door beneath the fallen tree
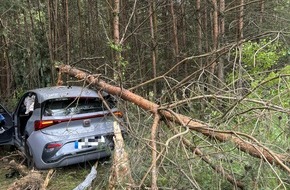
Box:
[0,86,122,169]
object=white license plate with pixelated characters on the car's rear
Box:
[75,136,105,149]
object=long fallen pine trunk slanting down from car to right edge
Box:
[57,65,290,173]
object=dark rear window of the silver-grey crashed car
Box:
[43,97,114,116]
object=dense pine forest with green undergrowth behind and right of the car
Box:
[0,0,290,189]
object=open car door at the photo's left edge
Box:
[0,104,14,145]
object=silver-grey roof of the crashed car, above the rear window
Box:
[28,86,108,103]
